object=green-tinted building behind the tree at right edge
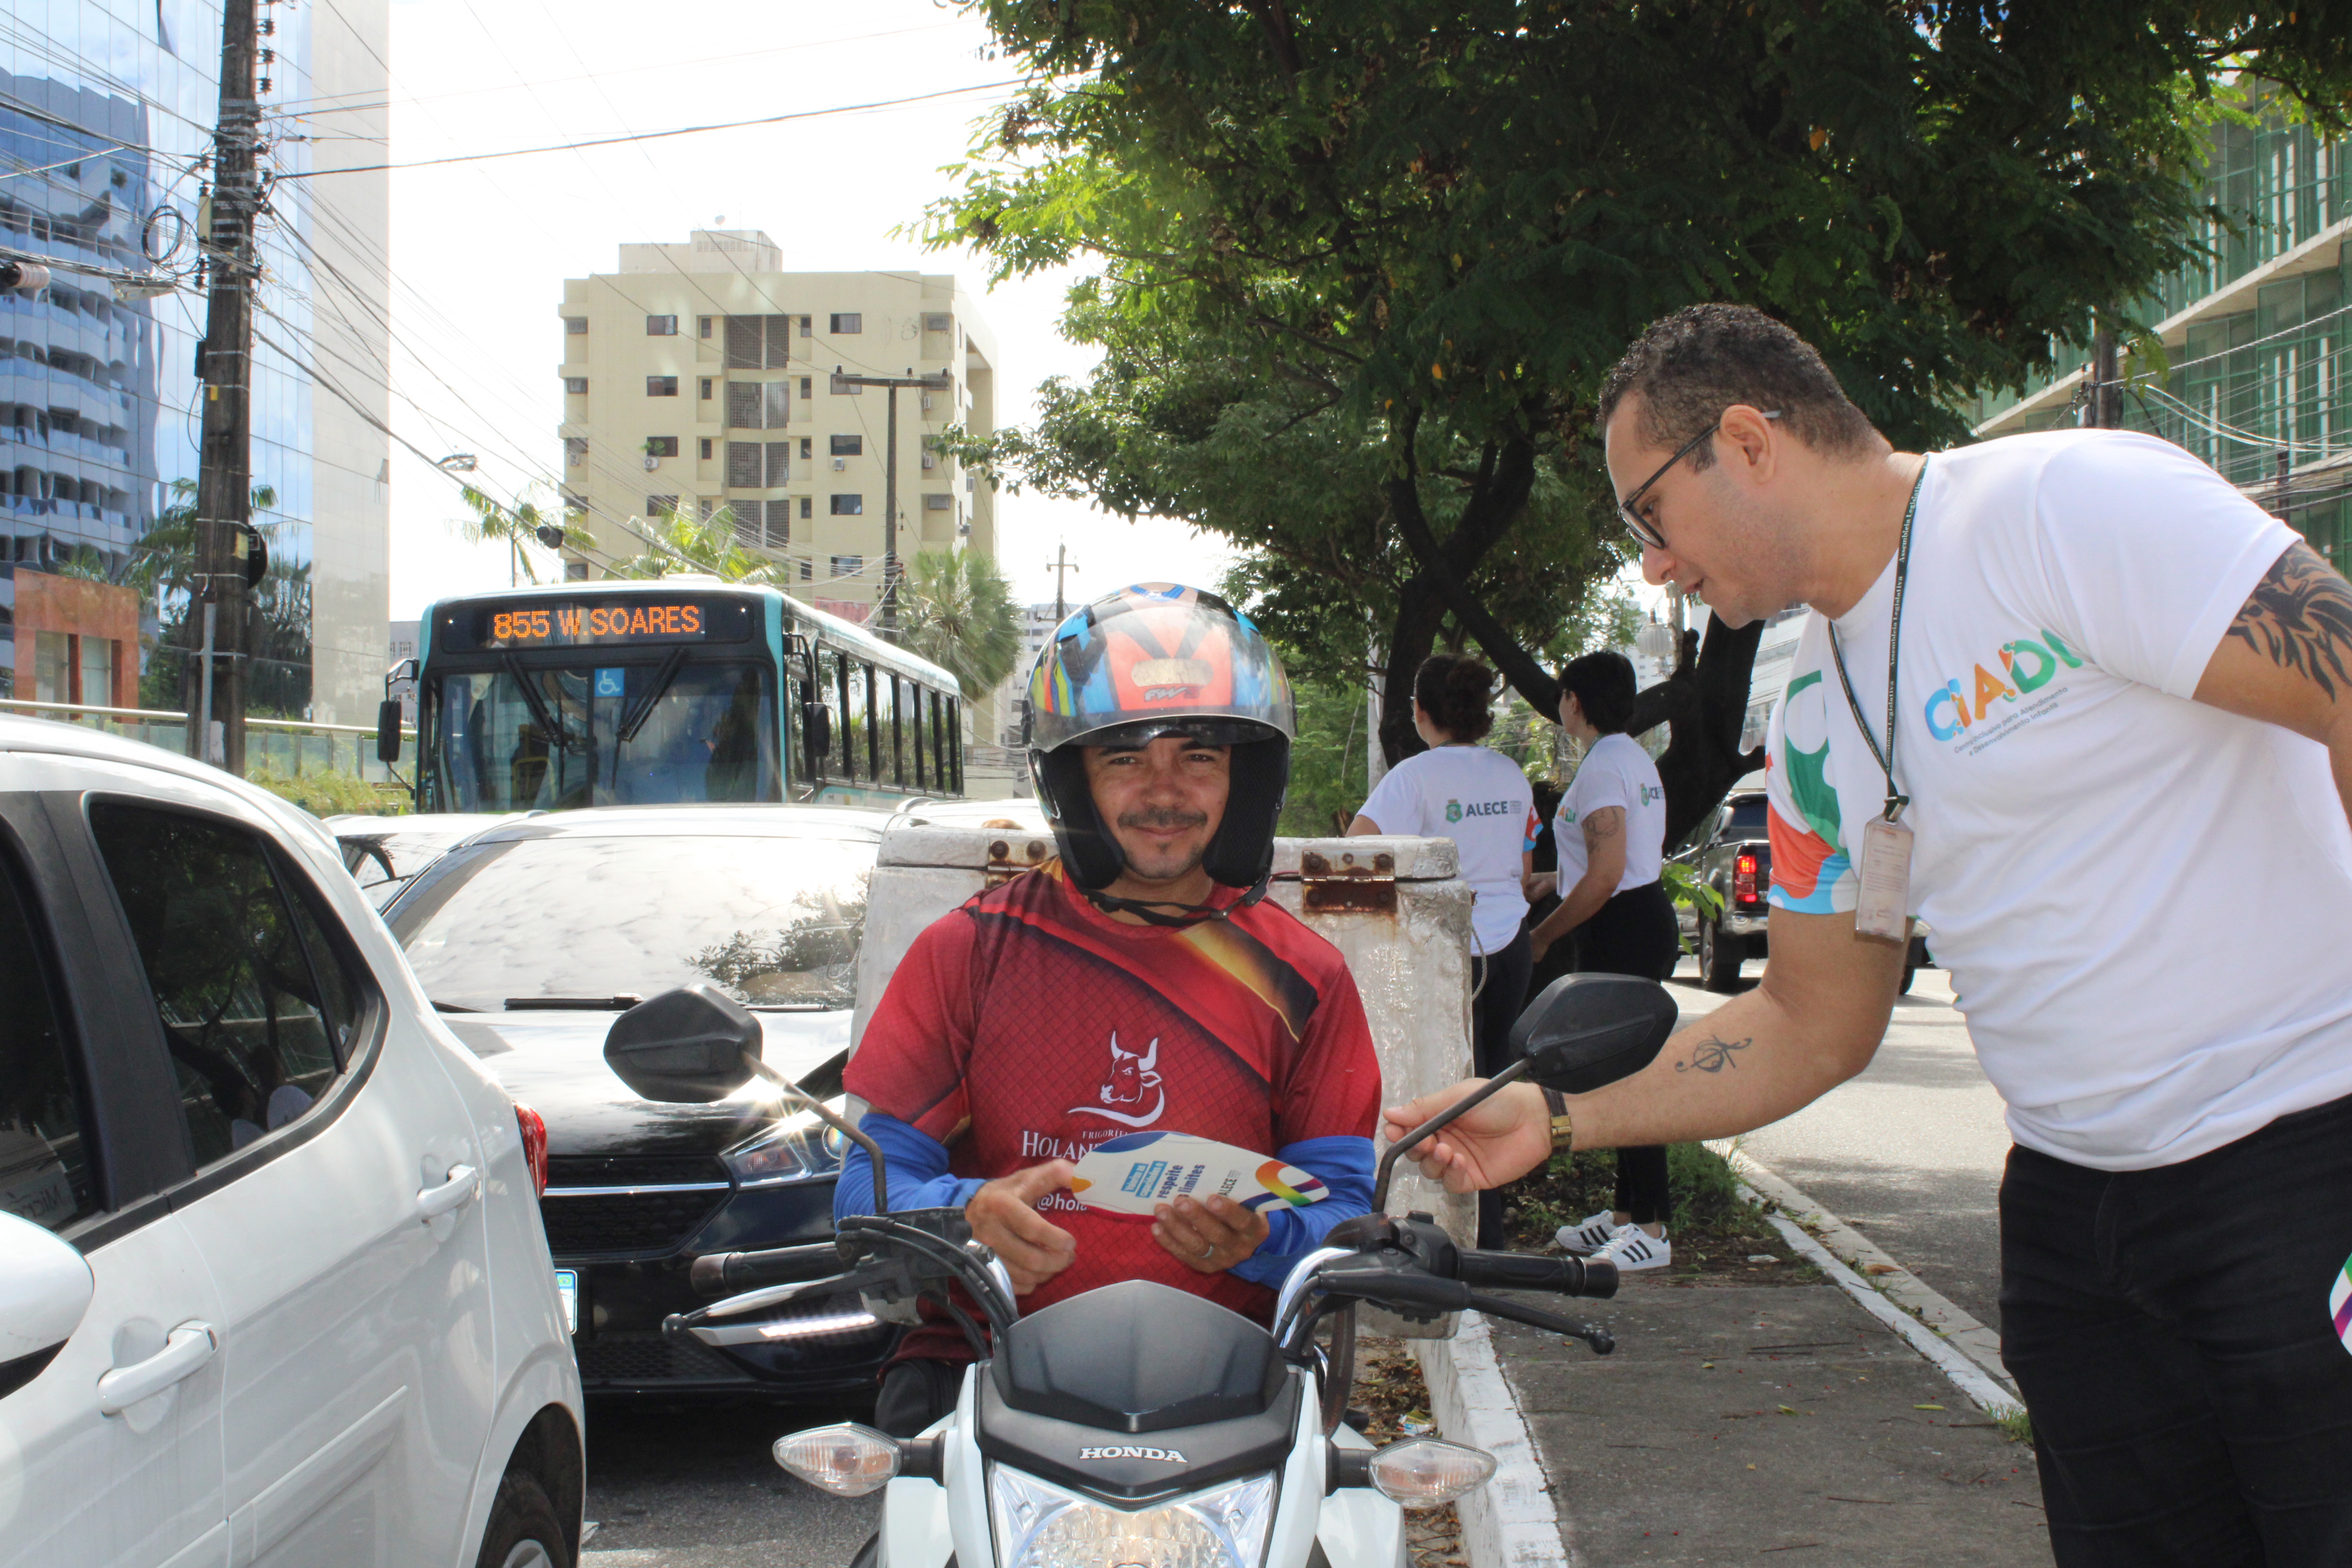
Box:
[1966,95,2352,569]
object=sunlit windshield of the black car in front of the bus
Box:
[390,835,875,1013]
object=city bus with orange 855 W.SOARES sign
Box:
[378,576,964,811]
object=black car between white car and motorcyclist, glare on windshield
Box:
[386,804,899,1396]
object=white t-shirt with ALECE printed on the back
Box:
[1364,745,1538,952]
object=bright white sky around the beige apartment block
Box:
[360,0,1230,620]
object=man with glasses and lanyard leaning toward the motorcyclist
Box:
[1390,306,2352,1568]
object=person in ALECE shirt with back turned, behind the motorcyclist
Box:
[1348,654,1536,1248]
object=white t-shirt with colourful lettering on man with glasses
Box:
[1766,430,2352,1171]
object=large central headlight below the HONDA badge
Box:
[988,1465,1275,1568]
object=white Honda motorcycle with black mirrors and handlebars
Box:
[605,976,1675,1568]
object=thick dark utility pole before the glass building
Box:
[188,0,261,778]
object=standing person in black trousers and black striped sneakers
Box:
[1529,654,1682,1269]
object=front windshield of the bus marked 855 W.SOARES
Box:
[426,658,783,811]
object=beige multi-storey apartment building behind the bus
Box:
[557,228,997,620]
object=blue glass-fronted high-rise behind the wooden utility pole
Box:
[0,0,390,724]
